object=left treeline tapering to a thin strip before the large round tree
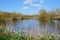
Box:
[0,11,38,21]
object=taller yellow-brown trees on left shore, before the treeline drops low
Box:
[0,11,23,20]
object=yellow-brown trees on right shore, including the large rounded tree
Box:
[39,9,60,20]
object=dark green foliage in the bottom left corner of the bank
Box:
[0,29,25,40]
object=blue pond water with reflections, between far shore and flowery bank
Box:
[6,19,60,36]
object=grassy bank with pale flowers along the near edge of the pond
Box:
[0,28,58,40]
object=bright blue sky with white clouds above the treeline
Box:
[0,0,60,15]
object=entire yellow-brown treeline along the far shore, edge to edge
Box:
[0,9,60,20]
